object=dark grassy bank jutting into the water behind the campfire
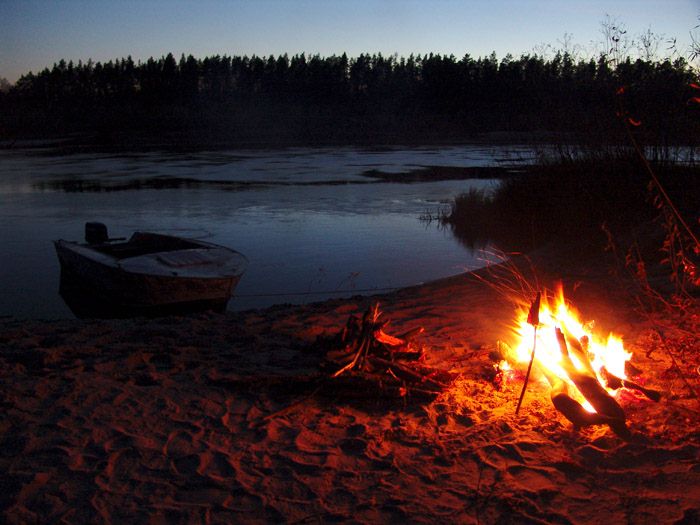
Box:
[440,152,700,266]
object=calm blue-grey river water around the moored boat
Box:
[0,146,529,318]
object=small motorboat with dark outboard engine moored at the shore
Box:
[54,223,248,317]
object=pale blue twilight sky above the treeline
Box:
[0,0,700,82]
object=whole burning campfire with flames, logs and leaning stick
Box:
[498,286,661,437]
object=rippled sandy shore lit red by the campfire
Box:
[0,248,700,525]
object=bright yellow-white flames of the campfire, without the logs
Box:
[501,286,632,412]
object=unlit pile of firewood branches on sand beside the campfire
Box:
[321,304,455,397]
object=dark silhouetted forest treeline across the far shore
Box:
[0,53,700,145]
